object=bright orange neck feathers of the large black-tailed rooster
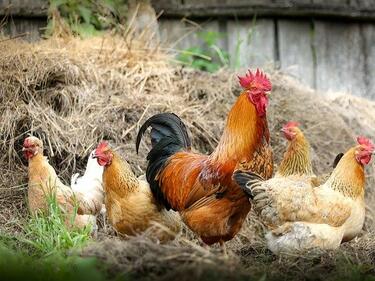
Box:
[210,92,269,163]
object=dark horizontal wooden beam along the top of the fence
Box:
[152,0,375,20]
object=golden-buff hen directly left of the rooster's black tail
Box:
[94,141,181,240]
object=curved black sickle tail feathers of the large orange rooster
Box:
[136,113,191,210]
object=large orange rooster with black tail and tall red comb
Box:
[136,70,273,245]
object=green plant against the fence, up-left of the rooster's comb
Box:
[177,31,229,72]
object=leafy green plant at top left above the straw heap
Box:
[46,0,127,37]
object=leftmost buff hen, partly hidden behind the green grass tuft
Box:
[22,136,96,229]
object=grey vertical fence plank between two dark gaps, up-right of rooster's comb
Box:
[278,20,315,87]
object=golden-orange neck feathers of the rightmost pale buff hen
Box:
[327,148,365,198]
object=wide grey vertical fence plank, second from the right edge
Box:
[314,21,366,96]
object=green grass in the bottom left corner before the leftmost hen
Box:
[0,190,113,281]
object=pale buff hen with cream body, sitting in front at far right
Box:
[233,137,375,253]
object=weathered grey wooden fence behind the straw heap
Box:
[0,0,375,98]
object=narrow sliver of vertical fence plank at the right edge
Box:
[361,24,375,99]
